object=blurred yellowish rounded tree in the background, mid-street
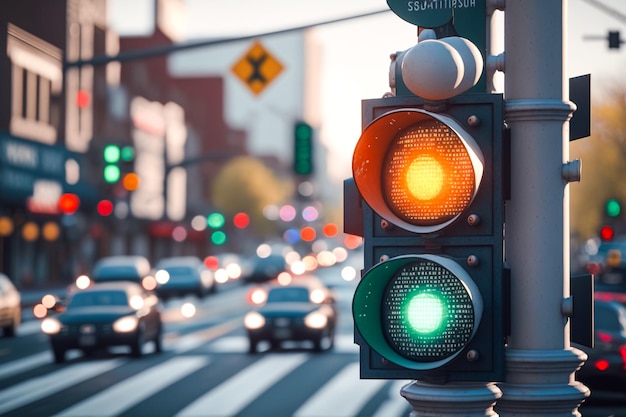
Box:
[212,156,293,237]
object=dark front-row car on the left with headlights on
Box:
[41,281,163,363]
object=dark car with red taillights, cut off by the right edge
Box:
[576,300,626,399]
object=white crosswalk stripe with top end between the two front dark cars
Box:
[55,356,209,417]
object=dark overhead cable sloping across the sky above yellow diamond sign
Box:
[64,9,391,69]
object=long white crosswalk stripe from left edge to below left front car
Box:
[0,359,124,414]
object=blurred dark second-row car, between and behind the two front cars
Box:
[155,256,217,300]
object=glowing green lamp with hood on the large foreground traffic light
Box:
[352,254,483,370]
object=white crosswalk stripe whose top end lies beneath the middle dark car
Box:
[176,354,308,417]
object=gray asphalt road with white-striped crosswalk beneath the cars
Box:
[0,260,626,417]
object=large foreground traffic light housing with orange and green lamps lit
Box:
[346,94,508,383]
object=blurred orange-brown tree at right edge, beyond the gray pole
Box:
[570,86,626,240]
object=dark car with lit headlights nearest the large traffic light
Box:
[244,277,337,353]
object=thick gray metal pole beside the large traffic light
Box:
[496,0,589,416]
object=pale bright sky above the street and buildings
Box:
[110,0,626,179]
